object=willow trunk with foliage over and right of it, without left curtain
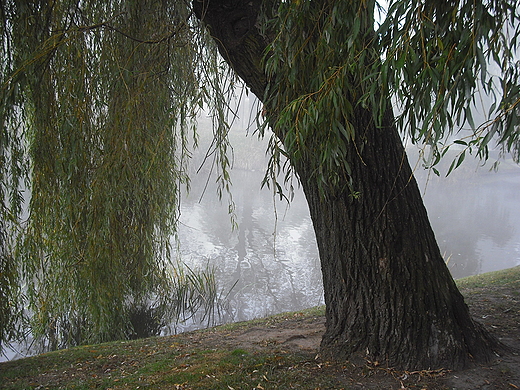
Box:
[193,0,520,368]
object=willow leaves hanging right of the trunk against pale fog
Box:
[378,0,520,168]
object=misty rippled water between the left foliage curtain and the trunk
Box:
[179,170,323,321]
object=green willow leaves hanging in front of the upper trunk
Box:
[265,1,378,194]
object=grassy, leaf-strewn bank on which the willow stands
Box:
[0,266,520,390]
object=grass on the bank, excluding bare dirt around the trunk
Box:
[0,267,520,390]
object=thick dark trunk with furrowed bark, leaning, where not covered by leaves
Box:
[194,0,497,369]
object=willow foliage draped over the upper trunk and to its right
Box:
[262,0,520,195]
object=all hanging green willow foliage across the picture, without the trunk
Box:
[0,0,520,368]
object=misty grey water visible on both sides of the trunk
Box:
[179,109,520,321]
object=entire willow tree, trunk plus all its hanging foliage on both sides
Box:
[0,0,520,368]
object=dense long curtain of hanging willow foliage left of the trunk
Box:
[0,0,235,348]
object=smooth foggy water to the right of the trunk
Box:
[416,150,520,278]
